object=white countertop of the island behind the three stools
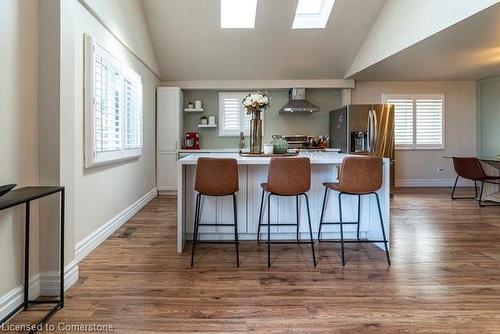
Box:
[177,152,389,165]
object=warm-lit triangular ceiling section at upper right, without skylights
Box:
[346,3,500,80]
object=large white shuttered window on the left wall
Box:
[85,35,142,168]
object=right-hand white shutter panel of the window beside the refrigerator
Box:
[415,98,443,148]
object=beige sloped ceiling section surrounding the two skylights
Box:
[143,0,385,81]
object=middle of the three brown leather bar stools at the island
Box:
[257,158,316,267]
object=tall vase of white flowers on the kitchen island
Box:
[242,91,270,154]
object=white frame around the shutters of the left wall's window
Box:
[84,34,144,168]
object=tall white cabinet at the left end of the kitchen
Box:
[156,87,183,194]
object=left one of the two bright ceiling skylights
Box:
[220,0,257,29]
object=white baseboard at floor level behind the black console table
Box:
[0,261,78,319]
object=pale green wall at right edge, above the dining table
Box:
[477,77,500,157]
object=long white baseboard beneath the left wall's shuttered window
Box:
[75,188,158,262]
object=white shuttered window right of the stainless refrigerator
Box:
[382,94,444,149]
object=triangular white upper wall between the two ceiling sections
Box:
[346,0,499,77]
